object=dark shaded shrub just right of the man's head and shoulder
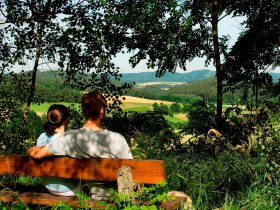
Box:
[104,111,180,150]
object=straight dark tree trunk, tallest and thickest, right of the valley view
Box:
[211,0,223,127]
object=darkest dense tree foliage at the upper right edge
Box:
[223,0,280,108]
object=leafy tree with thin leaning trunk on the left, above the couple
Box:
[0,0,130,123]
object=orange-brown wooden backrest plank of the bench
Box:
[0,155,166,184]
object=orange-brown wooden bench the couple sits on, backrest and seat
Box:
[0,155,186,209]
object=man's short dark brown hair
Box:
[82,90,107,120]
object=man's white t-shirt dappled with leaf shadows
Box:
[47,127,133,159]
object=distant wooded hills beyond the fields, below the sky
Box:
[35,70,280,104]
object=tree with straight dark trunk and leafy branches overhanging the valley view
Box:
[103,0,236,125]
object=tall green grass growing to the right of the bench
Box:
[162,152,280,210]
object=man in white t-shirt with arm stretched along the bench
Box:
[27,90,133,200]
